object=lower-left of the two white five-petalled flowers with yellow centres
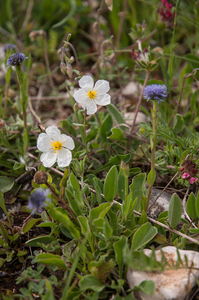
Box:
[37,126,75,168]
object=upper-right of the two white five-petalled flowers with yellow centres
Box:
[73,76,111,115]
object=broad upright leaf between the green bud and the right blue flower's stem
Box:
[130,173,146,211]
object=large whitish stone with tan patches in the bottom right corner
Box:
[127,246,199,300]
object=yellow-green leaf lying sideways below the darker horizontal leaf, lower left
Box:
[35,253,67,270]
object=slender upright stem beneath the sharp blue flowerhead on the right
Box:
[145,100,157,212]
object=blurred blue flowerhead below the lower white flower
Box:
[27,188,49,214]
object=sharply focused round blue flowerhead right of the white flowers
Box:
[143,84,168,103]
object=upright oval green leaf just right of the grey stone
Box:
[168,194,182,227]
